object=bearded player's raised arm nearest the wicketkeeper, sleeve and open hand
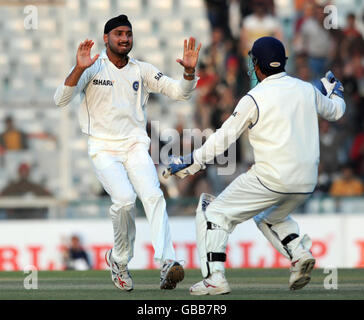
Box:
[141,37,201,100]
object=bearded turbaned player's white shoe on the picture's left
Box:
[105,249,134,291]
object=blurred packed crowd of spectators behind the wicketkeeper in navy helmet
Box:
[161,0,364,202]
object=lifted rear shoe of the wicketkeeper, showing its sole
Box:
[289,251,316,290]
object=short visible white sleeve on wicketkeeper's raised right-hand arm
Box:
[314,87,346,121]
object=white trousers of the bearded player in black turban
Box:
[88,137,176,264]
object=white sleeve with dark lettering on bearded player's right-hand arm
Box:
[140,62,198,100]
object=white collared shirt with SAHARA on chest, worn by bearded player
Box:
[54,50,198,144]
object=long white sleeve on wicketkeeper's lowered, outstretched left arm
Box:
[193,95,259,164]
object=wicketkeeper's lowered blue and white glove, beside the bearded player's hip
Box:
[162,153,206,179]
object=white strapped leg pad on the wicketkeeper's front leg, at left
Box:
[196,193,228,278]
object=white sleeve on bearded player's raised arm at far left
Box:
[54,66,93,107]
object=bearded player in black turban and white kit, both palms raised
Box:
[54,15,201,291]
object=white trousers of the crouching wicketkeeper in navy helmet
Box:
[205,170,310,272]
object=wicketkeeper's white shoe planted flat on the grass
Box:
[190,272,231,296]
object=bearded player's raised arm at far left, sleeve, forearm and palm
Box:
[54,39,99,107]
